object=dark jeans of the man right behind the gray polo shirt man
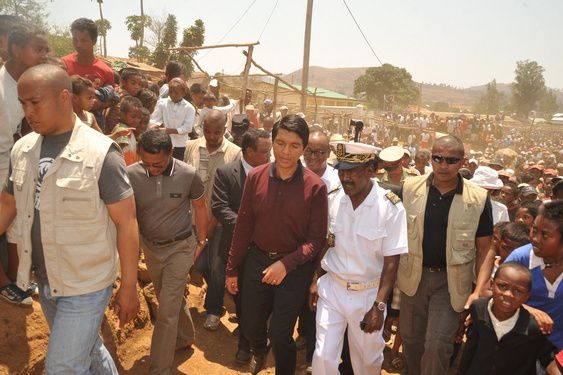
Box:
[195,226,225,316]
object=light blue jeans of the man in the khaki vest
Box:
[39,282,118,375]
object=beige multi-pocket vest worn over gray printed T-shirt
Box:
[11,118,119,297]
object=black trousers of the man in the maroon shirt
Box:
[242,247,313,375]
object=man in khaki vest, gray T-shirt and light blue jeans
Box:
[0,65,139,374]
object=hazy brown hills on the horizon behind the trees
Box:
[282,66,563,109]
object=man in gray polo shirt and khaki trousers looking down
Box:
[127,130,208,374]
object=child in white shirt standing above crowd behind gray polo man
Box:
[151,78,195,160]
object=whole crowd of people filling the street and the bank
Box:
[0,15,563,375]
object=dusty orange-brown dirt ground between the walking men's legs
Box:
[0,278,408,375]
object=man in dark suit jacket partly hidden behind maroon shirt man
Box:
[211,128,272,364]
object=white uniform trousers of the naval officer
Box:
[313,274,385,375]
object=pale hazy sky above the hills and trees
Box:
[46,0,563,89]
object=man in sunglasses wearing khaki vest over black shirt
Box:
[397,135,495,375]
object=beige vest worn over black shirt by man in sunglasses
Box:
[397,175,487,312]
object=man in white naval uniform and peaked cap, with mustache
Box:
[310,143,408,375]
